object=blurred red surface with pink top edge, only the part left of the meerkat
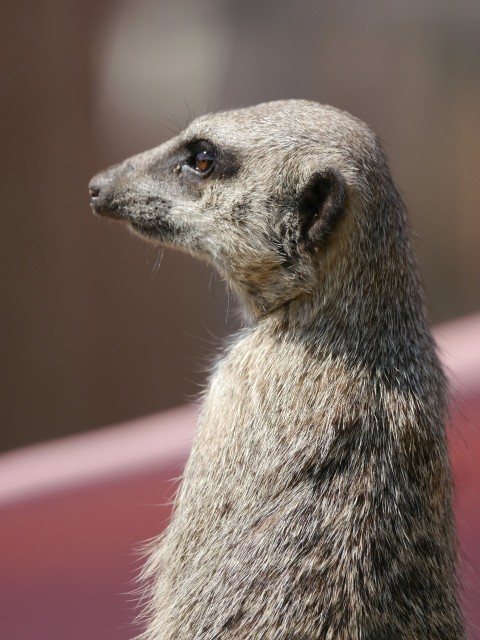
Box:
[0,409,195,640]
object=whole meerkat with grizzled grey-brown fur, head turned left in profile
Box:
[90,101,466,640]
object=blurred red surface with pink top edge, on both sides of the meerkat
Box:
[0,316,480,640]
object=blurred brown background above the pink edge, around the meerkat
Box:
[0,0,480,450]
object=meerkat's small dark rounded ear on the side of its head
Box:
[298,169,346,251]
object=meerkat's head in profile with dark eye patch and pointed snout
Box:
[90,100,396,317]
